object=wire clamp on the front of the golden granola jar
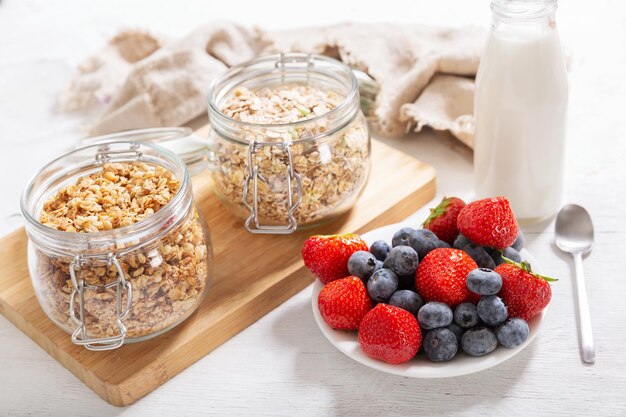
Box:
[69,253,133,351]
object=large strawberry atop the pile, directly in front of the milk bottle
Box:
[457,197,519,249]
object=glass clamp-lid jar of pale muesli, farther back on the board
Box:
[208,53,370,233]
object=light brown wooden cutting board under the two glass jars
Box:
[0,129,435,406]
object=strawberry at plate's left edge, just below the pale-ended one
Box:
[317,277,372,330]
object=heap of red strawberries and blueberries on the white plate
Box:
[302,197,553,364]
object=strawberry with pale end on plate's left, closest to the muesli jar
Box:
[302,233,368,284]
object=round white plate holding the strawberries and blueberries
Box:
[311,223,546,378]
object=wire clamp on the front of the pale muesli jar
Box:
[243,142,302,234]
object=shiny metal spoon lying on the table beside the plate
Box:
[555,204,596,364]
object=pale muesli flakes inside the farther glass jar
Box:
[213,85,370,225]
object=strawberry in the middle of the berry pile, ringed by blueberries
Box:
[415,248,478,308]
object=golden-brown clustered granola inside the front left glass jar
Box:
[33,162,210,338]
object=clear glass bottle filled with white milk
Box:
[474,0,567,220]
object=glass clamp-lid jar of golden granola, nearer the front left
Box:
[21,142,212,350]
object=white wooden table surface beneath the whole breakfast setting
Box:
[0,0,626,416]
